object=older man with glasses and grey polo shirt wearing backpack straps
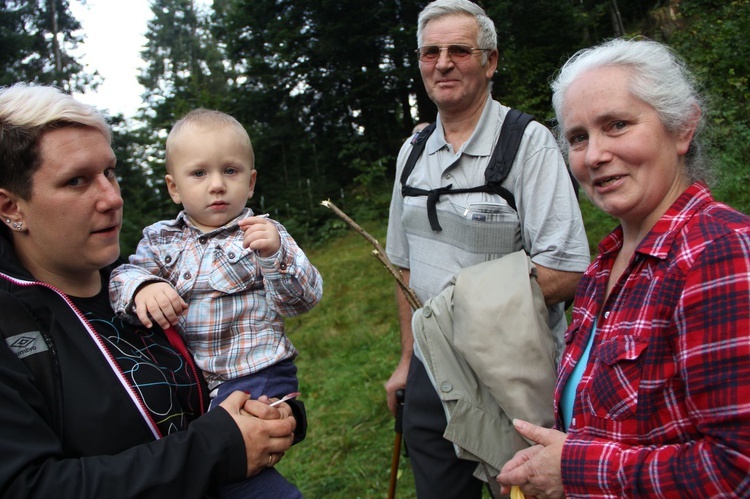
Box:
[386,0,589,499]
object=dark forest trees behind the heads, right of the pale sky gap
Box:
[110,0,750,242]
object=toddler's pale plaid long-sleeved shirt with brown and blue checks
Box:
[110,209,323,388]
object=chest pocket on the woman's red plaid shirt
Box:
[585,336,648,421]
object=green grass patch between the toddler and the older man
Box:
[277,221,416,498]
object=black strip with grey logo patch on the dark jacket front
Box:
[0,291,62,430]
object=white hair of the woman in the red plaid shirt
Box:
[551,38,712,181]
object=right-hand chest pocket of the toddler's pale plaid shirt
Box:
[208,245,263,294]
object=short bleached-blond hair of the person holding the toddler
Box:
[0,83,112,200]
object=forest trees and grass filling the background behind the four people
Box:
[0,0,750,498]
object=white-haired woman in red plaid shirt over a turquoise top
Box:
[497,39,750,497]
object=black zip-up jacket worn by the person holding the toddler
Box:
[0,235,306,499]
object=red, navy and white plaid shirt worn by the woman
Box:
[555,183,750,498]
